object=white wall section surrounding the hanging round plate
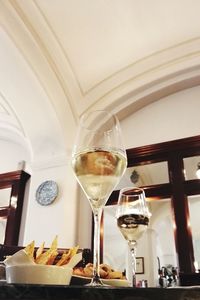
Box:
[20,164,77,247]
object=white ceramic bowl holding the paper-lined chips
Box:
[6,264,73,285]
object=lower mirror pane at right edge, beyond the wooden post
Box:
[188,195,200,272]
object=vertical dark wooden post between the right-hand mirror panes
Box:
[168,153,195,273]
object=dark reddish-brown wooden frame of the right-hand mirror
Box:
[100,136,200,283]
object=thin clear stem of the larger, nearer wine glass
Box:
[93,208,102,282]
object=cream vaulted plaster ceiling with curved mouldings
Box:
[0,0,200,164]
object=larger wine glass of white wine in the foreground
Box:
[72,110,127,286]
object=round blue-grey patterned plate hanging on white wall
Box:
[36,180,58,205]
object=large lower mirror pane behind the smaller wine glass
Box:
[103,199,177,287]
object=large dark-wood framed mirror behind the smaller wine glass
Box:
[101,136,200,286]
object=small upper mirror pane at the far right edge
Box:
[183,156,200,180]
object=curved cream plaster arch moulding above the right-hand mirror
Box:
[91,38,200,119]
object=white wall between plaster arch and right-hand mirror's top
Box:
[121,86,200,148]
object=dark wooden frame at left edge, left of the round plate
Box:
[0,170,30,245]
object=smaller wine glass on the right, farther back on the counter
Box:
[116,187,150,287]
